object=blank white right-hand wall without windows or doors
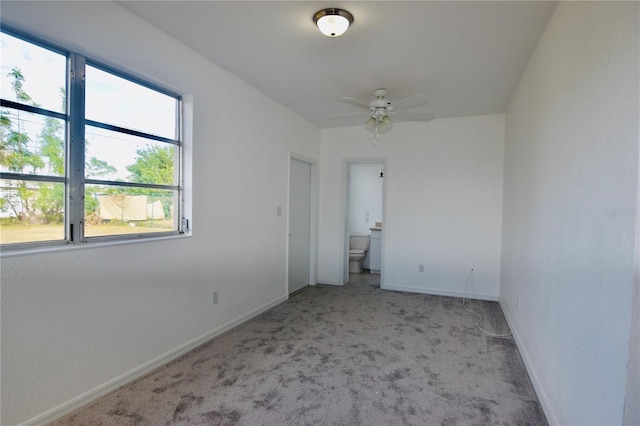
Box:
[500,2,639,425]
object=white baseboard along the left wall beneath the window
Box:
[22,295,288,426]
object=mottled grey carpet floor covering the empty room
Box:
[54,274,547,426]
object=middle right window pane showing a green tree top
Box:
[85,126,177,185]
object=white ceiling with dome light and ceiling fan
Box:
[118,0,557,127]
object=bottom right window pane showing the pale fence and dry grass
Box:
[84,185,178,237]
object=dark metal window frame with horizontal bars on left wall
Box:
[0,25,189,252]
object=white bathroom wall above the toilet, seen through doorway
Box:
[349,163,383,234]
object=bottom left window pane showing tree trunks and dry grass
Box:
[0,179,64,244]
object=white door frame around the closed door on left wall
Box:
[285,151,318,298]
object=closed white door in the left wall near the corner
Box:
[288,158,311,294]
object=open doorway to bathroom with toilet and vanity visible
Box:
[345,160,385,281]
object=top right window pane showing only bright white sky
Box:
[85,65,177,139]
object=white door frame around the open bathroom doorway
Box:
[338,157,388,288]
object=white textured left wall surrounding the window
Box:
[0,2,320,425]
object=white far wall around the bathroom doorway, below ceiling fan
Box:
[318,114,504,299]
